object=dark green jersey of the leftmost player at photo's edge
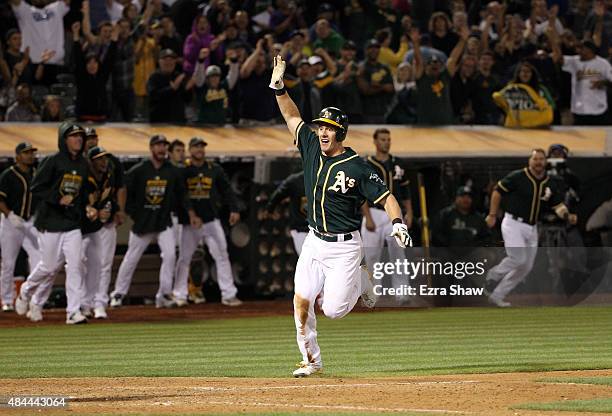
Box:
[0,165,34,221]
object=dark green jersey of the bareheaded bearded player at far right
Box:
[496,168,563,225]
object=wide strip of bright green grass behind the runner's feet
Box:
[0,307,612,378]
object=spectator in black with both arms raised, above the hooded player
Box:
[72,22,119,122]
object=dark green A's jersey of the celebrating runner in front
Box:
[295,121,389,234]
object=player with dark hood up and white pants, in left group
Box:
[15,122,97,324]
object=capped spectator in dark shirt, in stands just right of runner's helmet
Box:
[357,39,394,124]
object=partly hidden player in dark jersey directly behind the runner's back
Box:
[266,171,308,256]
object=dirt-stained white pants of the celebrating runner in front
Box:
[293,231,367,366]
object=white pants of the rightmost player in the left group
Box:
[173,219,238,300]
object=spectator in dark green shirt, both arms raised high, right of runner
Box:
[411,28,469,125]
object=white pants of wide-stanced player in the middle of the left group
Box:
[111,227,176,300]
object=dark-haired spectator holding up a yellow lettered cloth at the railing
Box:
[493,62,553,127]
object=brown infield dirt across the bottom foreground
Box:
[0,370,612,416]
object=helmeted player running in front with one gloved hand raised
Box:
[270,56,411,377]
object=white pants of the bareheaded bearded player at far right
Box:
[487,214,538,300]
